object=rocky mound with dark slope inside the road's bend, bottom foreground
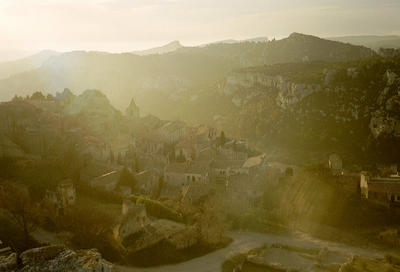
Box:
[117,198,230,266]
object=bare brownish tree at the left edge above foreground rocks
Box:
[0,182,38,243]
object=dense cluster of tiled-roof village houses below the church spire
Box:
[86,112,265,202]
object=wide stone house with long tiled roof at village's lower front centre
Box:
[164,160,210,186]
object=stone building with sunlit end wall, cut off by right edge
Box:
[360,172,400,206]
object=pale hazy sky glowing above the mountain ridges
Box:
[0,0,400,52]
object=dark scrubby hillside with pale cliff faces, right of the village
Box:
[218,58,400,163]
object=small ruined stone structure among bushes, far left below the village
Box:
[45,179,76,214]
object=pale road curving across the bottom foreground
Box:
[119,232,383,272]
